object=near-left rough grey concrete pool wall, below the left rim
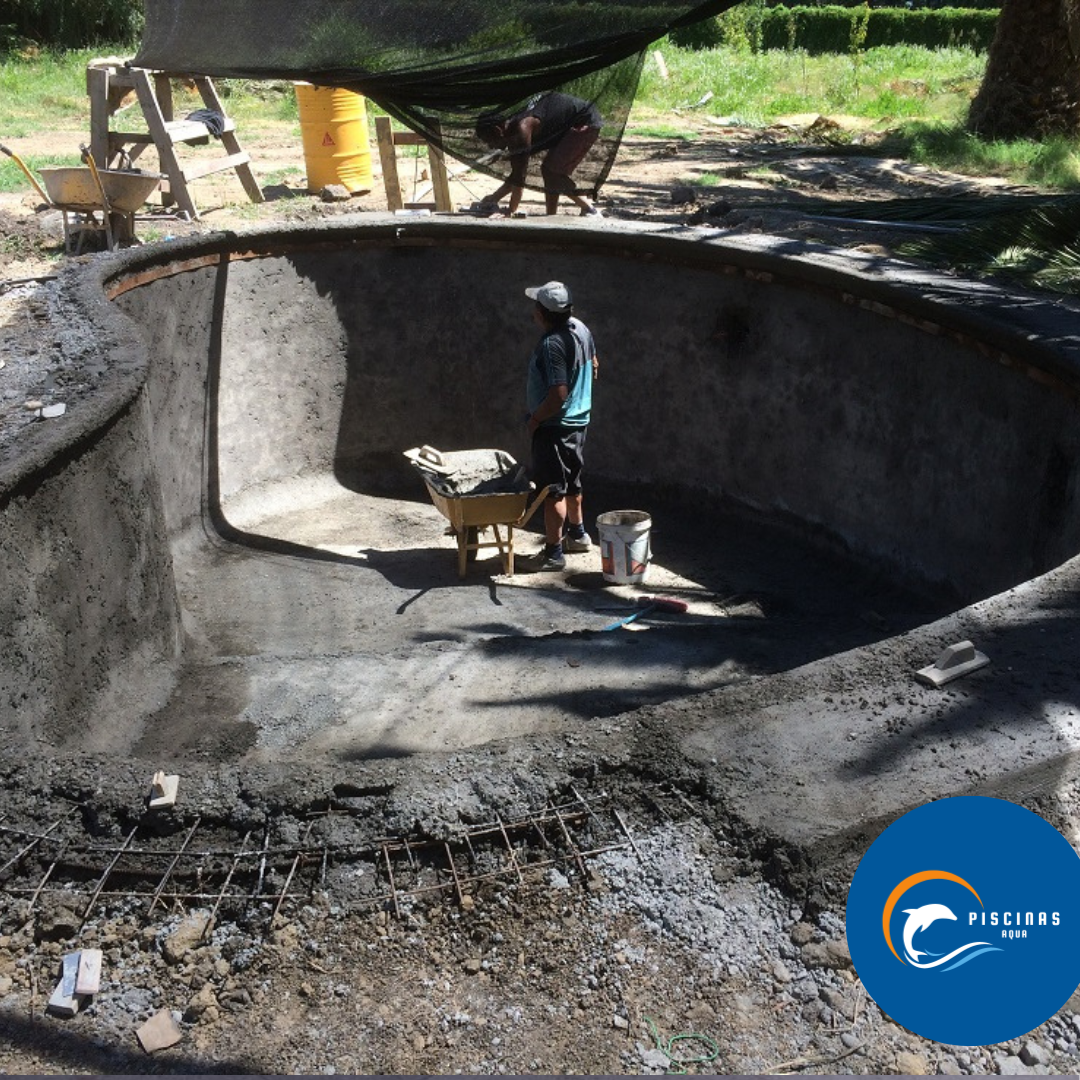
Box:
[0,396,178,746]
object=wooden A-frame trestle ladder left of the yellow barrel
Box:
[86,60,262,218]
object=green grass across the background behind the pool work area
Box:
[0,40,1080,191]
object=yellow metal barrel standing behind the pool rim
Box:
[295,82,373,194]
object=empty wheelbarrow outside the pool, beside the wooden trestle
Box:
[0,144,164,252]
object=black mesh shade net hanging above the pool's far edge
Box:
[133,0,738,193]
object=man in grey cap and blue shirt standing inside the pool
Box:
[522,281,599,570]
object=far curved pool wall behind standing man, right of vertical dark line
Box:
[204,234,1080,599]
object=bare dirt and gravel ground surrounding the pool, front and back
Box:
[0,118,1080,1075]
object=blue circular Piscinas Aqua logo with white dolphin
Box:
[848,796,1080,1047]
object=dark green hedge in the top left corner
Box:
[0,0,143,50]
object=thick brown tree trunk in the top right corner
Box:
[968,0,1080,138]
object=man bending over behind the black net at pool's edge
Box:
[476,92,603,217]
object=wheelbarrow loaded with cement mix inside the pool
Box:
[405,446,551,578]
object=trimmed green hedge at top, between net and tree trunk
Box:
[671,4,998,54]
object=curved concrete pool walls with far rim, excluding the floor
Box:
[0,218,1080,803]
